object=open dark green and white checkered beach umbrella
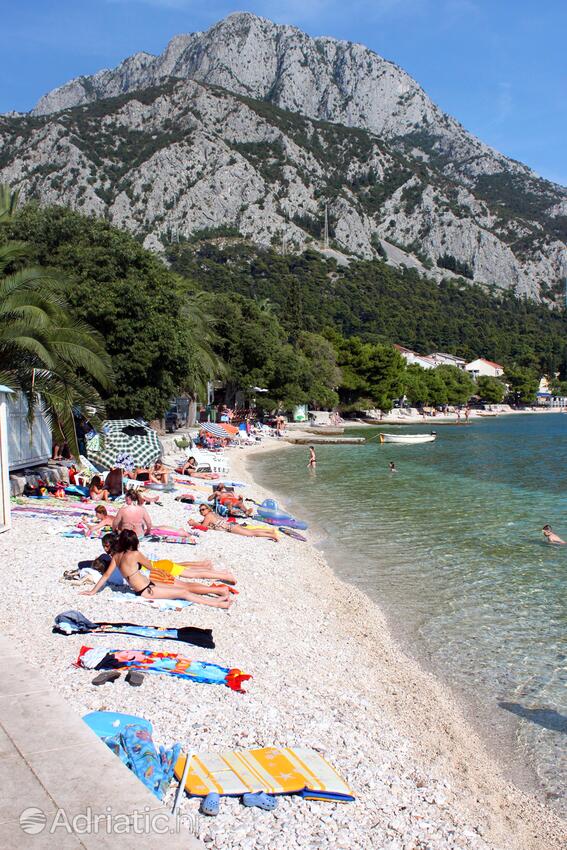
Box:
[87,419,163,470]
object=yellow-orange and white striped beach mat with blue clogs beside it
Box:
[175,747,354,803]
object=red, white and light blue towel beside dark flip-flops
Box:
[75,646,252,693]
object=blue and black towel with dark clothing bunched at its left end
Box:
[53,611,215,649]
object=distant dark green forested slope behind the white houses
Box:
[167,241,567,376]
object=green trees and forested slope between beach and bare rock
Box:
[3,204,567,419]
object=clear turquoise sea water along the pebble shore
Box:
[253,414,567,811]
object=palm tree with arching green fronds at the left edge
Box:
[0,185,112,453]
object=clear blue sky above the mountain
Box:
[4,0,567,185]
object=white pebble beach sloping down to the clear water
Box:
[0,442,567,850]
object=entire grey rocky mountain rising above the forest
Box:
[0,13,567,298]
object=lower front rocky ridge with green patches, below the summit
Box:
[0,73,563,297]
